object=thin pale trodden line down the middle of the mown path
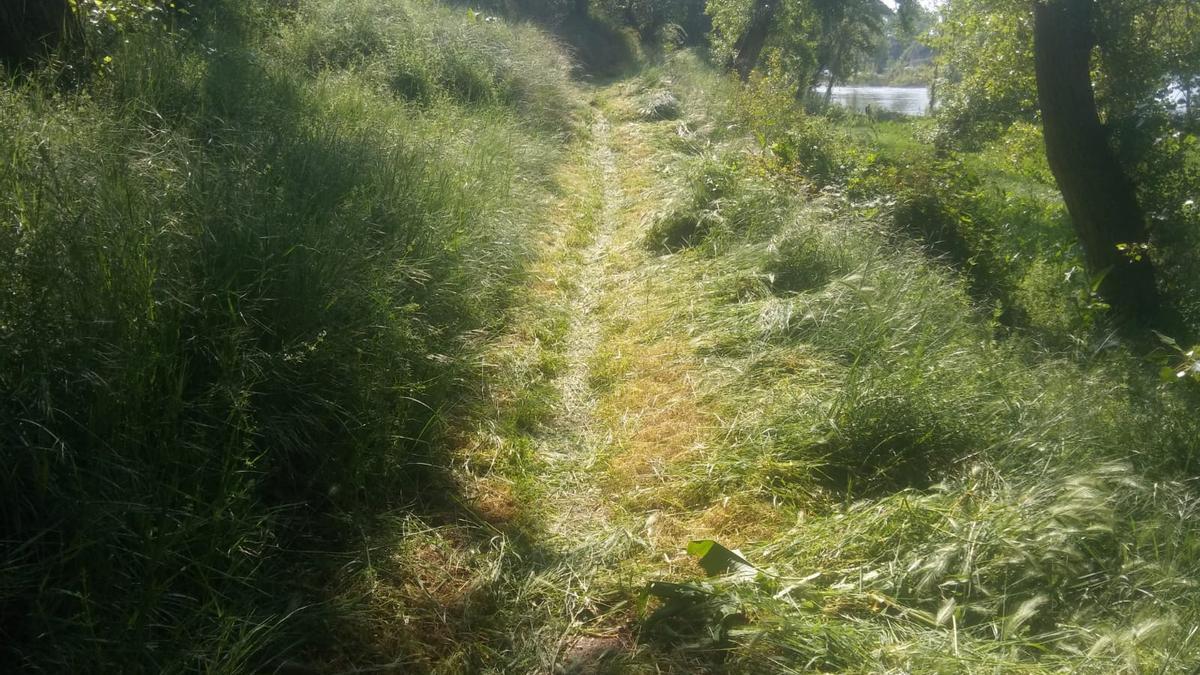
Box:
[526,103,630,671]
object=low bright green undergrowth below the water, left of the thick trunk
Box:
[737,76,1106,336]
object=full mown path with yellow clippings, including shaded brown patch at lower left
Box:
[350,79,788,673]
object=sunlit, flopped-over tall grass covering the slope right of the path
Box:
[628,51,1200,673]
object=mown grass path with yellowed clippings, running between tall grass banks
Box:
[467,80,734,673]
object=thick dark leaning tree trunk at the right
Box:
[1033,0,1158,319]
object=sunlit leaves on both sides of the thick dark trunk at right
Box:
[935,0,1200,325]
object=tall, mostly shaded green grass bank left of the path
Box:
[0,0,575,673]
